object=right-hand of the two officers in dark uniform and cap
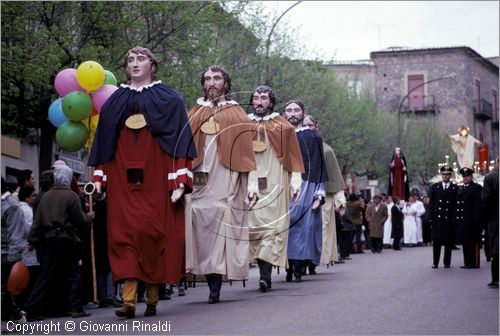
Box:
[455,167,483,268]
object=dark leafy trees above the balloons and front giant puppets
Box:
[1,1,258,136]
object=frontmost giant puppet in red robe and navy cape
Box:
[89,47,196,318]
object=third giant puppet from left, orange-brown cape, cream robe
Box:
[248,85,304,292]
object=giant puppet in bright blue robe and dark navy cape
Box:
[284,100,328,282]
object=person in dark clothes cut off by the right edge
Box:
[481,157,498,288]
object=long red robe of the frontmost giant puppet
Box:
[89,81,193,284]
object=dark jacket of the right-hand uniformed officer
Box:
[455,182,483,242]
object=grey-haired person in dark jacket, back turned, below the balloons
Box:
[26,166,94,321]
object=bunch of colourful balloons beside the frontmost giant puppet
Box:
[49,61,118,152]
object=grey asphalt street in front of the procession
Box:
[4,246,499,335]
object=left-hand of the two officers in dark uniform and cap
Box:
[429,165,458,268]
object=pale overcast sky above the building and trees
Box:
[262,1,500,61]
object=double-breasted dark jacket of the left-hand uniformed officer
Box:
[429,182,458,241]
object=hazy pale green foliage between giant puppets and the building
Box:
[262,59,387,180]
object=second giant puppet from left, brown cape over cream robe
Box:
[186,65,258,304]
